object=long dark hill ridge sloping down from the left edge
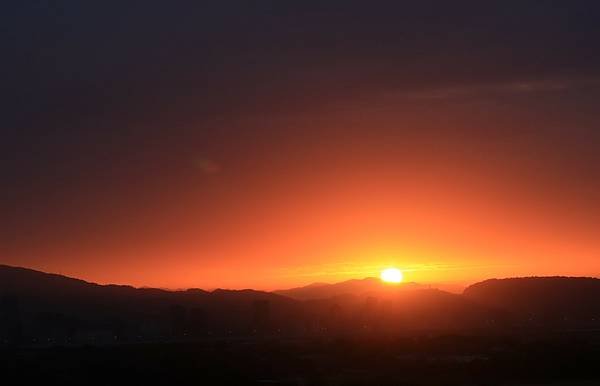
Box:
[0,265,300,342]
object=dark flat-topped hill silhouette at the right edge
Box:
[464,277,600,327]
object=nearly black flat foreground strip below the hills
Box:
[0,333,600,386]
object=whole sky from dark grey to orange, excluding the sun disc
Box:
[0,0,600,289]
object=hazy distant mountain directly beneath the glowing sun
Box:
[274,277,427,300]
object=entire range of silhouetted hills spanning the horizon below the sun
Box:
[0,266,600,345]
